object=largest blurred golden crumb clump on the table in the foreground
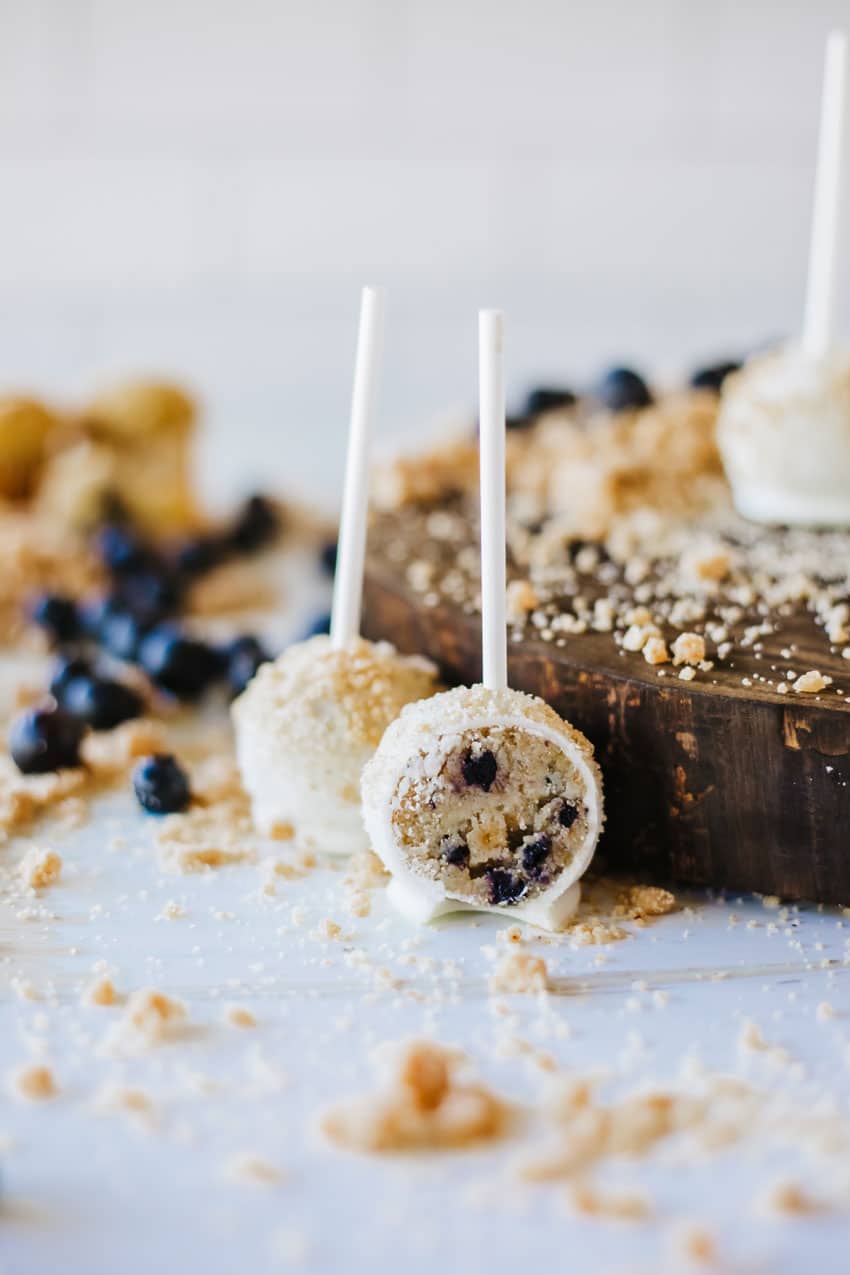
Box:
[321,1040,507,1153]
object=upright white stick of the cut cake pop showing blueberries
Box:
[478,310,507,691]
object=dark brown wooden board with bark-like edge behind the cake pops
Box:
[363,515,850,904]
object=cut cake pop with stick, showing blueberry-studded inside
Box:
[362,311,603,929]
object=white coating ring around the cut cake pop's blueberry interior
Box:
[362,686,604,929]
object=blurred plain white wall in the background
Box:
[0,0,850,499]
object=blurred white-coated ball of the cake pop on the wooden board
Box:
[717,347,850,527]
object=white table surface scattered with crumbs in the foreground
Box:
[0,540,850,1275]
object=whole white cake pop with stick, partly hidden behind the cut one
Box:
[233,288,438,854]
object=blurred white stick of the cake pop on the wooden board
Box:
[803,31,847,358]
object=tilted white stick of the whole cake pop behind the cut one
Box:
[330,288,386,648]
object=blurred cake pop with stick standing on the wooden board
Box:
[717,32,850,527]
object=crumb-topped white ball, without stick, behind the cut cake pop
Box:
[232,635,438,854]
